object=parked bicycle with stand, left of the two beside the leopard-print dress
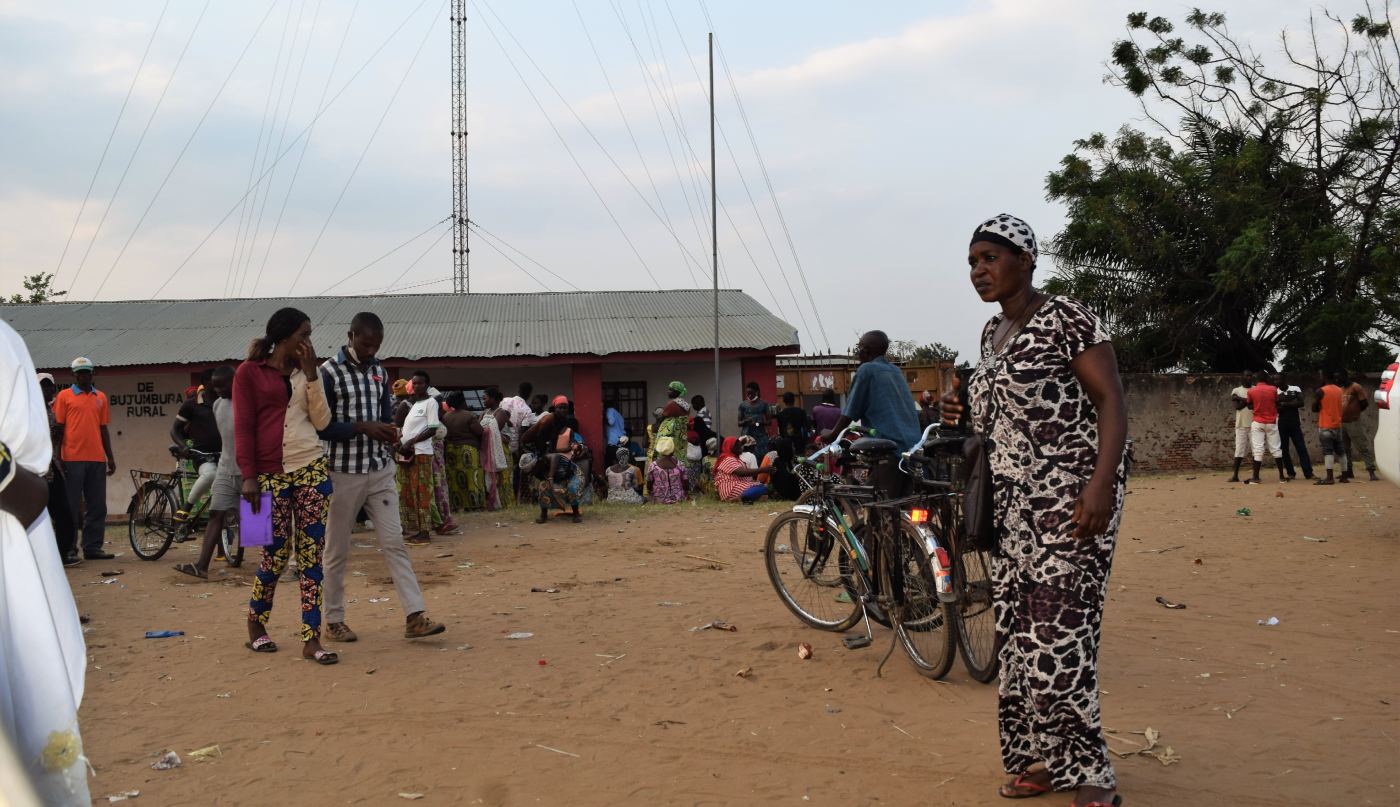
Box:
[764,427,956,678]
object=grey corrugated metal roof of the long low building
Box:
[0,290,798,367]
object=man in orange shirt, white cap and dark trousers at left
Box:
[53,356,116,560]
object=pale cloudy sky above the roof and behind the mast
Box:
[0,0,1359,357]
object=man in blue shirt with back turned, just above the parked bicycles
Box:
[822,331,923,451]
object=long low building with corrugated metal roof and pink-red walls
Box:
[0,290,798,513]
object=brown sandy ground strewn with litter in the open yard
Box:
[70,475,1400,806]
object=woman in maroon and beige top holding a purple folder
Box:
[234,308,340,664]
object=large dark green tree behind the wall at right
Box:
[1046,4,1400,371]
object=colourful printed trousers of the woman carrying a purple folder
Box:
[248,457,330,642]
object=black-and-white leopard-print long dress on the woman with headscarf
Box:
[969,297,1126,790]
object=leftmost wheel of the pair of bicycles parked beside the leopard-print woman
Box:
[763,511,861,630]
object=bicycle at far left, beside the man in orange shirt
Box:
[126,446,244,567]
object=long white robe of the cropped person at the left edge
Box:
[0,321,92,806]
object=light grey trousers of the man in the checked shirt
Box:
[321,462,423,623]
